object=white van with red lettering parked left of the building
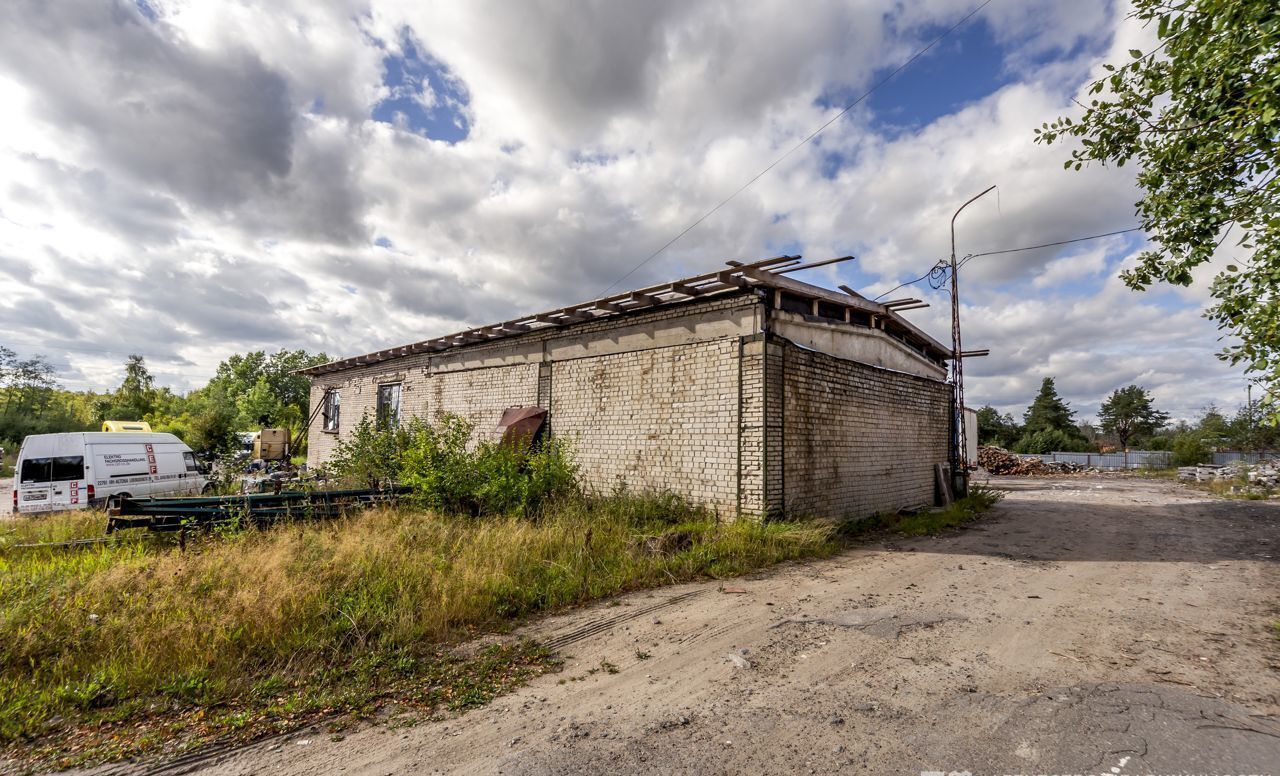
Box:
[13,432,209,512]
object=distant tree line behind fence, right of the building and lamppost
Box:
[978,378,1280,465]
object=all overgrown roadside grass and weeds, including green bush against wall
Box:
[0,417,998,766]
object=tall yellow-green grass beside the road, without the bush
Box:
[0,494,836,763]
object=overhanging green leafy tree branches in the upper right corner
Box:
[1037,0,1280,409]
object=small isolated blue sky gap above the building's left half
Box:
[372,31,471,143]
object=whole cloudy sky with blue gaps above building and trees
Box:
[0,0,1244,417]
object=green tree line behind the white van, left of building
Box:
[0,346,329,453]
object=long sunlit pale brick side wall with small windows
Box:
[308,293,760,516]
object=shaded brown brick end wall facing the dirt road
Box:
[769,342,951,517]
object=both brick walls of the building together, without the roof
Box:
[308,293,950,516]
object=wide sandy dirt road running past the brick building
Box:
[122,476,1280,775]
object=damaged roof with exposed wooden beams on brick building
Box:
[298,256,951,375]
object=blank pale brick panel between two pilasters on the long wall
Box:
[550,337,740,516]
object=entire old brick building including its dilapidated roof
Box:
[301,256,952,517]
